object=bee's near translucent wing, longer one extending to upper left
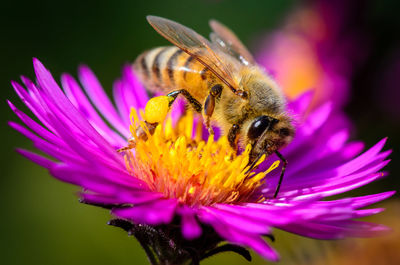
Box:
[147,16,237,92]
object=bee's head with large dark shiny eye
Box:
[246,115,294,161]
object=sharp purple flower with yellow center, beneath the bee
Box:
[9,59,394,264]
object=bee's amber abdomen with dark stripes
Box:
[134,46,216,102]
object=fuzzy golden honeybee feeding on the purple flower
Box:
[133,16,294,197]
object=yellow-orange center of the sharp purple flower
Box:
[125,109,279,205]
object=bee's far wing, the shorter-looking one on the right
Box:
[210,20,255,65]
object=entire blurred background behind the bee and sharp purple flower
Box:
[0,0,400,265]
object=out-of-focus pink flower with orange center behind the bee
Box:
[258,0,368,107]
